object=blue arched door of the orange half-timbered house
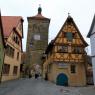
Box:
[56,73,68,86]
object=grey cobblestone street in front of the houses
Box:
[0,78,95,95]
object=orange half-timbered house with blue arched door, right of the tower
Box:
[43,16,88,86]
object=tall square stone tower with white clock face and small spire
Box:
[26,7,50,73]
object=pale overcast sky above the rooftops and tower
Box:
[0,0,95,54]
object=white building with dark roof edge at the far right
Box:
[87,15,95,85]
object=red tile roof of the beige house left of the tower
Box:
[2,16,22,37]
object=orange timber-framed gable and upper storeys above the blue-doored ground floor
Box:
[54,16,87,62]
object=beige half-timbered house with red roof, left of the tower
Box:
[1,16,23,81]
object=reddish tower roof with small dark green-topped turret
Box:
[28,6,50,20]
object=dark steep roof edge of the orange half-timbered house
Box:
[55,16,88,46]
